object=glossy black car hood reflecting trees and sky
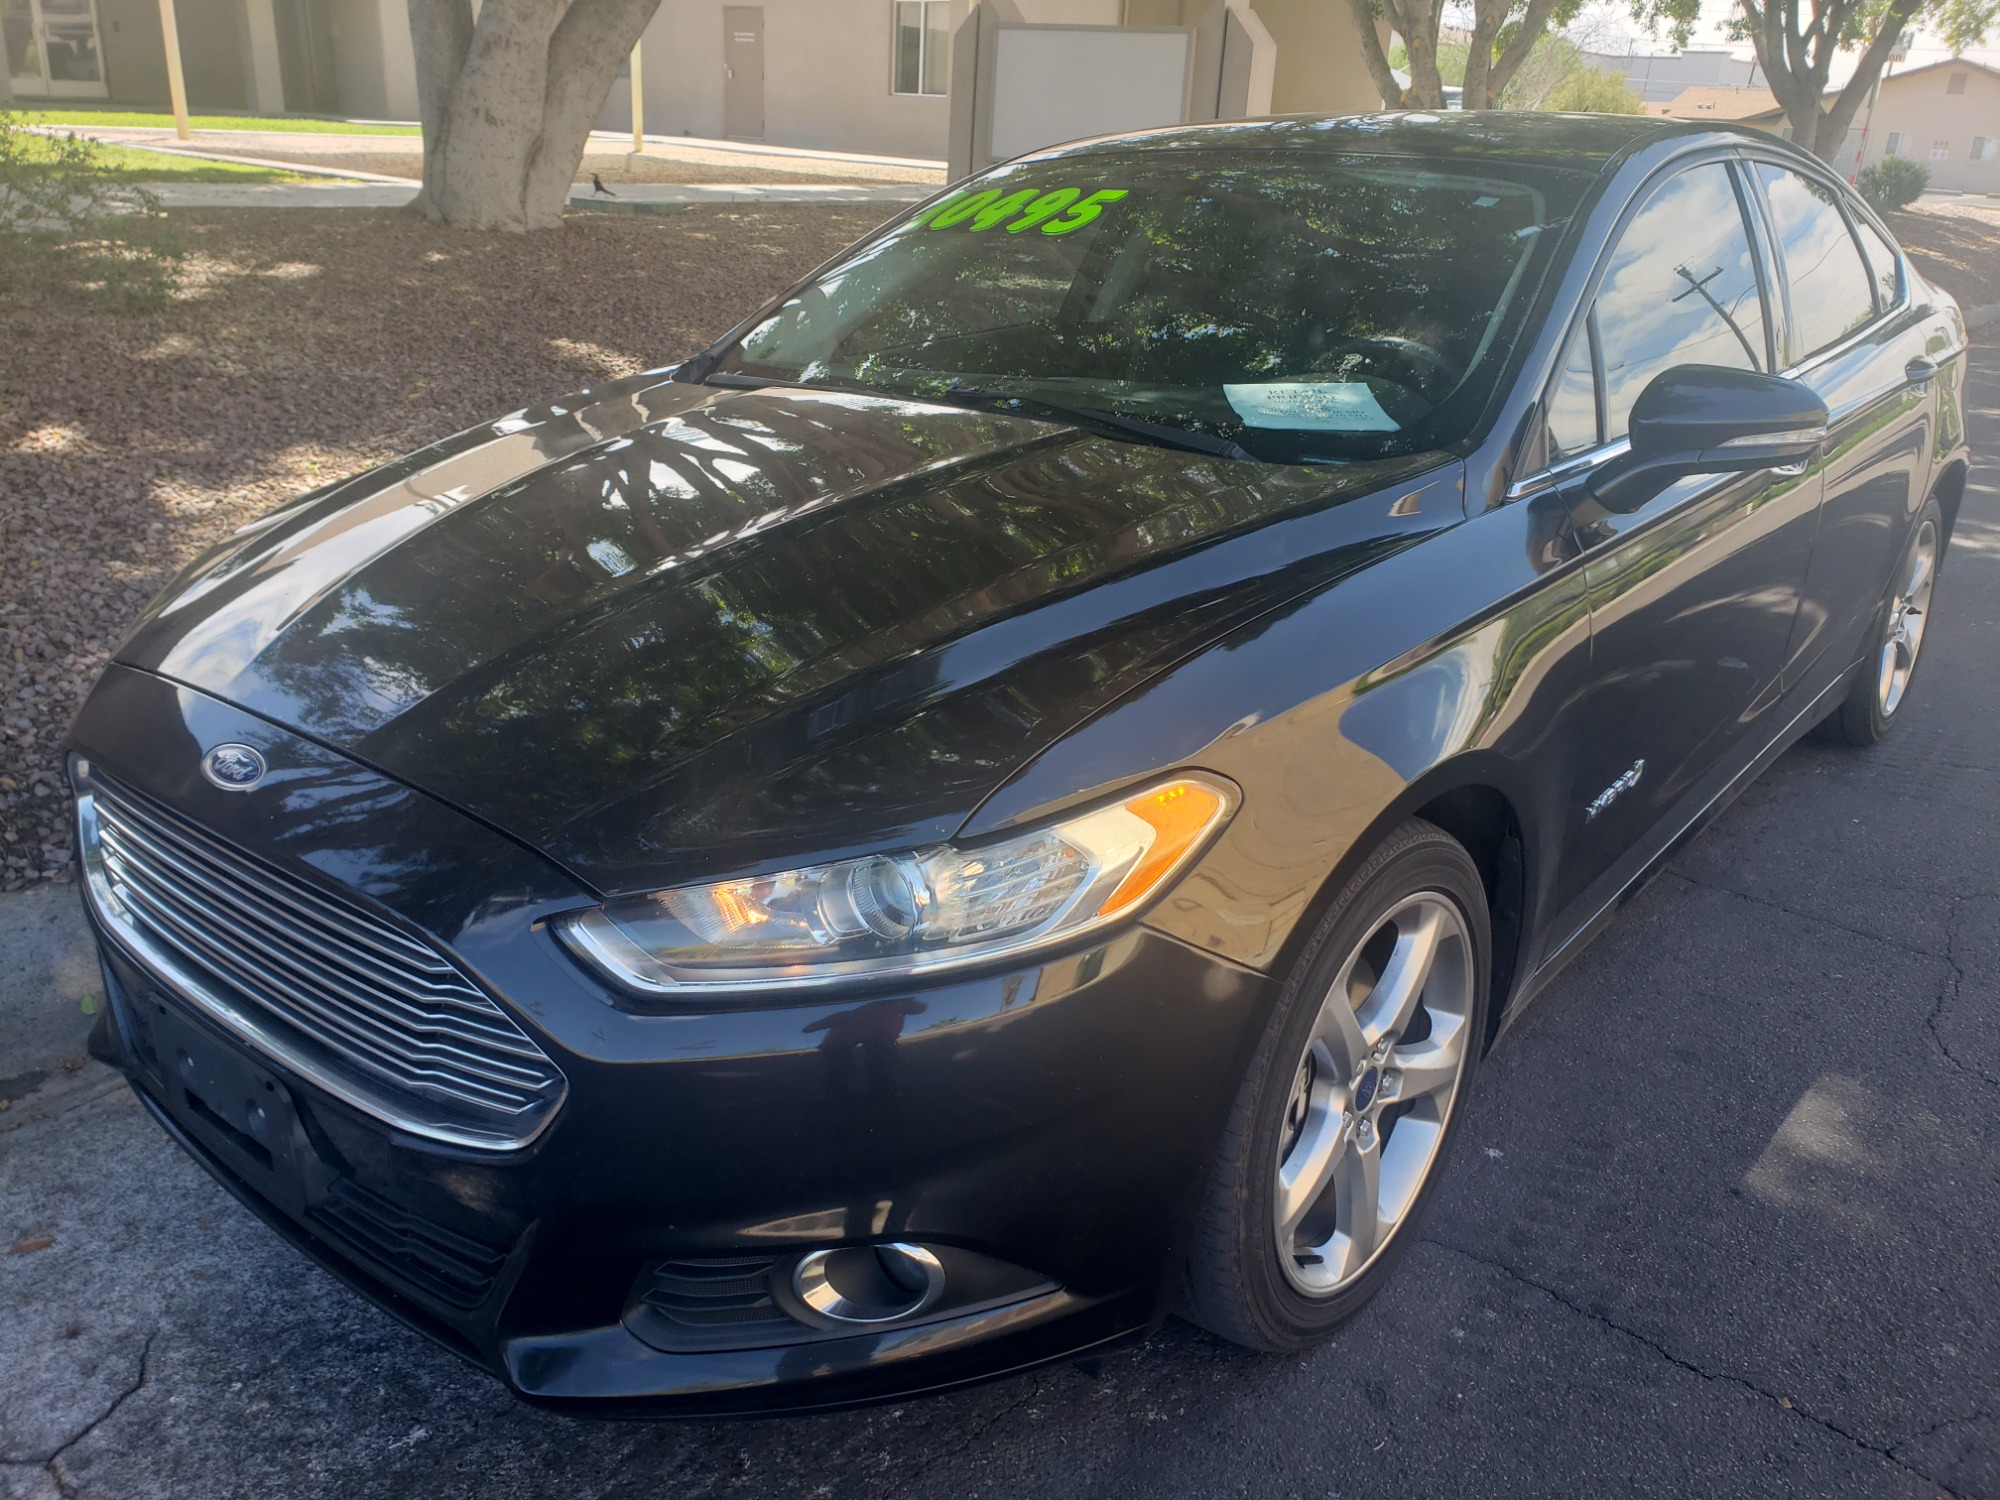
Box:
[118,374,1462,892]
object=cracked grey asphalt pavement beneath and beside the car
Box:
[0,350,2000,1500]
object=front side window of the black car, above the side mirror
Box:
[1596,162,1766,440]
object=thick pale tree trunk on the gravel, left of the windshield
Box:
[410,0,660,230]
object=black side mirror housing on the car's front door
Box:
[1590,364,1826,510]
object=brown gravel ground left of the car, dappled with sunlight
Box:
[0,208,882,890]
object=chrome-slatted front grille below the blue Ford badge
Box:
[76,766,564,1150]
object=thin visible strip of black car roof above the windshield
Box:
[1026,110,1776,172]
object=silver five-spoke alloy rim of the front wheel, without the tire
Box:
[1272,892,1474,1298]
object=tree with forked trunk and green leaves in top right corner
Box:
[1632,0,2000,160]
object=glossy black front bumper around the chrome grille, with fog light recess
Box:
[72,668,1270,1416]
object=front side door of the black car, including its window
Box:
[1550,160,1820,926]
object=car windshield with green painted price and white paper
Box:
[700,150,1590,462]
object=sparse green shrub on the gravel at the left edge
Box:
[0,110,186,308]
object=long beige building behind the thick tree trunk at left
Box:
[0,0,1380,160]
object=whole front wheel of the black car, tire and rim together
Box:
[1180,820,1492,1352]
